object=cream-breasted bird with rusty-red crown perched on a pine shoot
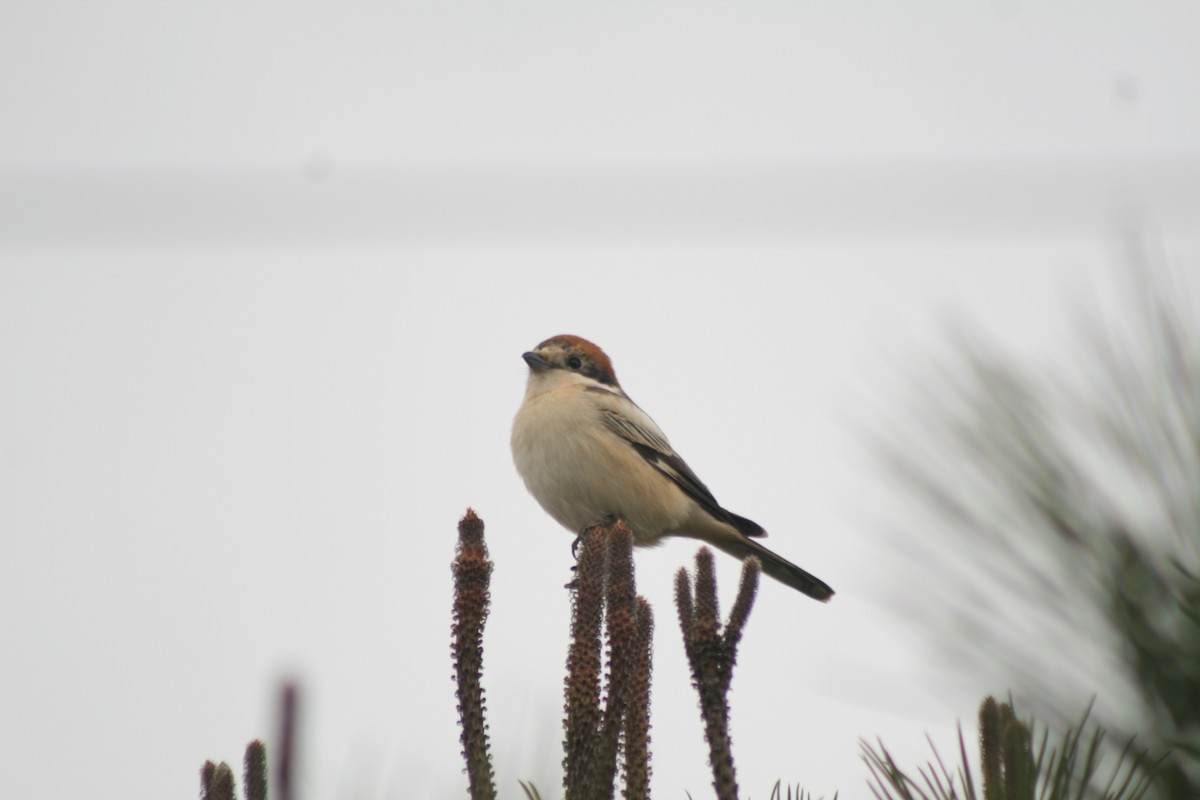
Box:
[511,333,834,602]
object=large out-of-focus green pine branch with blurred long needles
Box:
[888,254,1200,800]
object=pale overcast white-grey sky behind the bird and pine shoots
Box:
[0,0,1200,799]
